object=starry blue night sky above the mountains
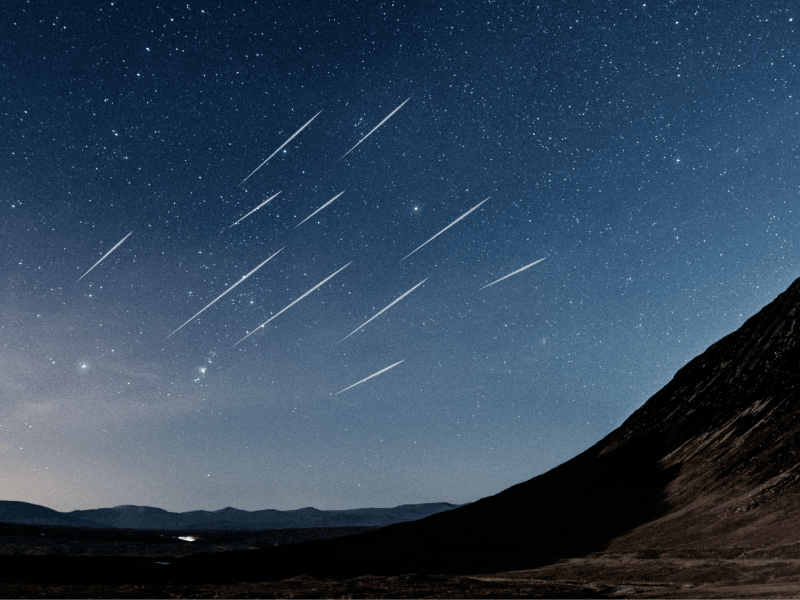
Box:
[0,0,800,511]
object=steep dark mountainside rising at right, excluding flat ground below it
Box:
[3,279,800,582]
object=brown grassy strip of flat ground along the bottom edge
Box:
[0,554,800,598]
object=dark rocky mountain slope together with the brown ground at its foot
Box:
[0,280,800,597]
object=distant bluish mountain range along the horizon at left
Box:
[0,500,458,530]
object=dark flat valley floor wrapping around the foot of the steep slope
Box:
[0,523,800,598]
